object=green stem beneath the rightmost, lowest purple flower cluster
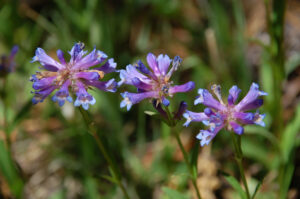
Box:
[230,132,251,199]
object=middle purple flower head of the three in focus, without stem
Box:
[118,53,195,110]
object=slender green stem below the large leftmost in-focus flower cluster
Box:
[79,107,130,199]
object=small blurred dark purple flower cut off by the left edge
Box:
[0,45,19,77]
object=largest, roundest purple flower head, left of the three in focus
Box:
[30,43,117,110]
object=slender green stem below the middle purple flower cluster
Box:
[165,107,201,199]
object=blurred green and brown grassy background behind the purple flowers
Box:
[0,0,300,199]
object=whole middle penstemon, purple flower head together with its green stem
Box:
[119,53,201,199]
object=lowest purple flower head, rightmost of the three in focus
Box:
[183,83,267,146]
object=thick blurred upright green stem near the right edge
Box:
[266,0,287,198]
